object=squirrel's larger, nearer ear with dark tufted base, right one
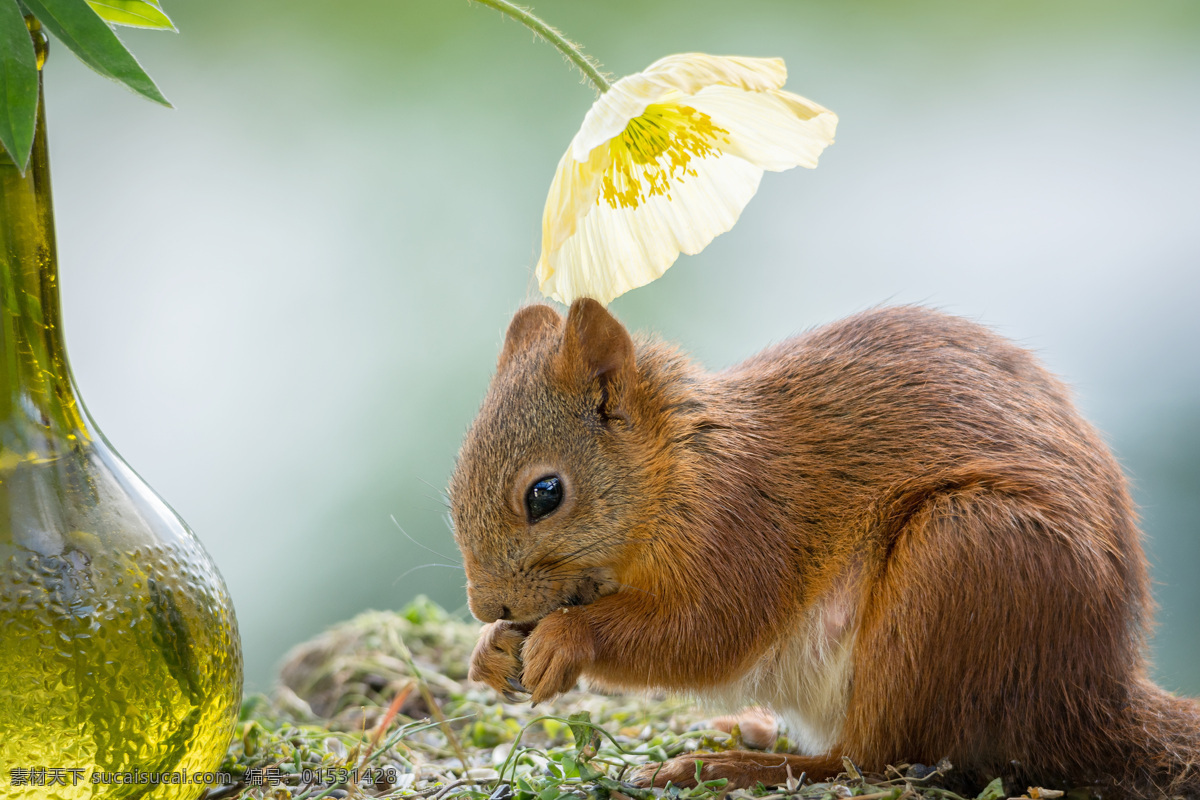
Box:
[560,297,635,416]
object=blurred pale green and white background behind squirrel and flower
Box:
[32,0,1200,693]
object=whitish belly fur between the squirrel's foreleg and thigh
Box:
[697,581,856,756]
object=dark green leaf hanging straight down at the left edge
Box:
[0,0,37,173]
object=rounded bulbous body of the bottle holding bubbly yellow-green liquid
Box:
[0,440,241,800]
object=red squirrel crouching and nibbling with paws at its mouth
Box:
[450,299,1200,798]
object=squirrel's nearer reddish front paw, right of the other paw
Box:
[521,608,595,704]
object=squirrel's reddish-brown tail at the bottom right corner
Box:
[1120,680,1200,800]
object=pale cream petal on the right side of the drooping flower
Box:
[688,86,838,172]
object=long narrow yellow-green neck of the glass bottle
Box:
[0,19,88,453]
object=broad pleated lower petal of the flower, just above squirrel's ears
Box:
[538,155,762,303]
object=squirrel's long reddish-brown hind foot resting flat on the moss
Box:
[632,750,844,789]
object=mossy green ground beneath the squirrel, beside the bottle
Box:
[205,599,1057,800]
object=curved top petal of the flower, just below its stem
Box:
[571,53,787,162]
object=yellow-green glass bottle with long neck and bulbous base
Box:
[0,19,241,800]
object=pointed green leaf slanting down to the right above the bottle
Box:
[22,0,170,107]
